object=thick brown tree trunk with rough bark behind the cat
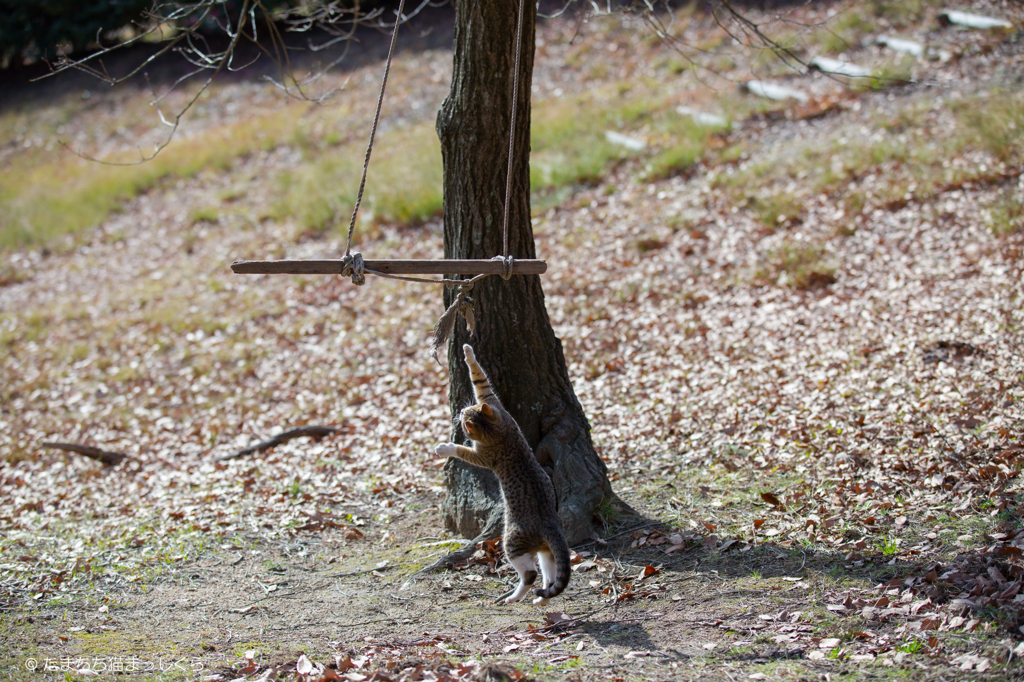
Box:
[437,0,615,545]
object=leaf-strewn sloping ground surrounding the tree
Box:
[0,3,1024,682]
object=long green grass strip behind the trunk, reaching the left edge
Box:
[0,73,761,249]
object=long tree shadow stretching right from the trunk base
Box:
[578,507,1024,638]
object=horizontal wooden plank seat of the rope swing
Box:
[231,258,548,274]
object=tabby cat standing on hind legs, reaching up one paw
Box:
[434,344,571,605]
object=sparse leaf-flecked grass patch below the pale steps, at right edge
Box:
[709,87,1024,215]
